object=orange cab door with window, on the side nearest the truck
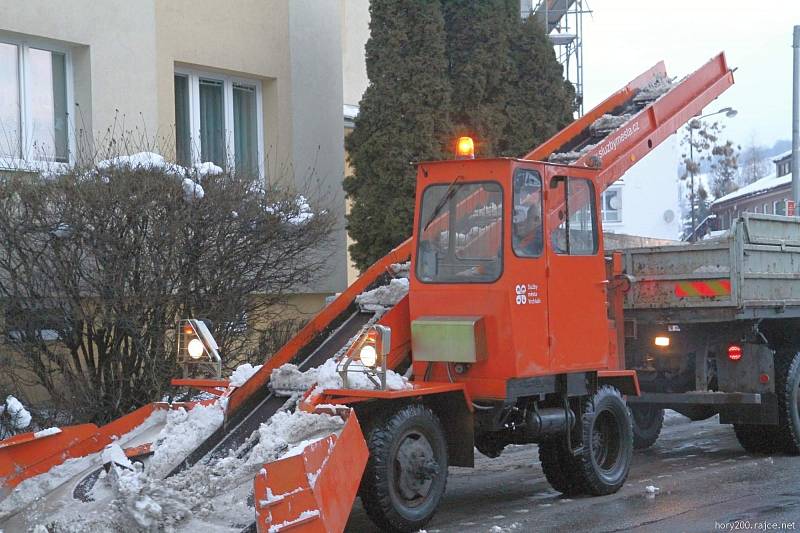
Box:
[545,167,609,373]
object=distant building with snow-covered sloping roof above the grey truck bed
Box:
[711,150,792,230]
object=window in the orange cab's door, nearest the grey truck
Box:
[550,177,598,255]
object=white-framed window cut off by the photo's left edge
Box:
[0,36,72,167]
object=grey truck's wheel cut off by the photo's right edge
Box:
[775,352,800,455]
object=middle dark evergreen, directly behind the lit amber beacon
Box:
[442,0,520,157]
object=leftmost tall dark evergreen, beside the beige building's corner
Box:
[344,0,451,270]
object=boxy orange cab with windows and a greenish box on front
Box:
[409,154,610,398]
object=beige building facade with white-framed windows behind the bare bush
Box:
[0,0,346,304]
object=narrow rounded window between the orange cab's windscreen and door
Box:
[511,168,544,257]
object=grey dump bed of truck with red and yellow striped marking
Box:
[622,213,800,323]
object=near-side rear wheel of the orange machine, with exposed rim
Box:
[576,385,633,496]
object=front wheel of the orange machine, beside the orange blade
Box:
[359,404,447,533]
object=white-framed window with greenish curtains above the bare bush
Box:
[175,69,263,176]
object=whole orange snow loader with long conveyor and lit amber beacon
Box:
[0,54,750,532]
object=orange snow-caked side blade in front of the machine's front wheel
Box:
[253,409,369,533]
